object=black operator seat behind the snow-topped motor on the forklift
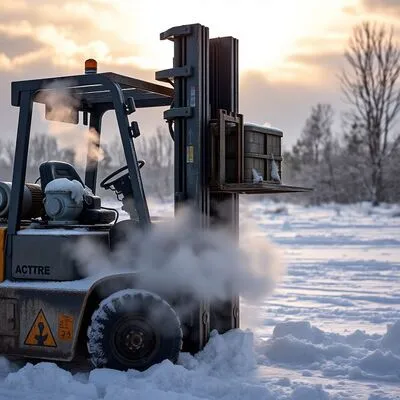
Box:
[39,161,115,225]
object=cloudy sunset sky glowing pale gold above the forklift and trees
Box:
[0,0,400,152]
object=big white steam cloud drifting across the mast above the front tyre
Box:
[75,211,284,302]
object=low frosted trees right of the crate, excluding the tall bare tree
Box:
[283,104,400,204]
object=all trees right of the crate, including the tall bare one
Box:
[285,22,400,205]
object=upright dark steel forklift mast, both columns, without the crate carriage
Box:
[156,24,239,340]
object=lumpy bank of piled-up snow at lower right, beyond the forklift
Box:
[259,321,400,382]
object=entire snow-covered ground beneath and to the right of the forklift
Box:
[0,202,400,400]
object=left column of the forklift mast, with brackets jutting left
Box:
[156,24,210,353]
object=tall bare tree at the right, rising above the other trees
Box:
[341,22,400,205]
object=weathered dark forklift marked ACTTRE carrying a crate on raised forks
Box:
[0,24,307,371]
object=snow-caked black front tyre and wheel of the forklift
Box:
[87,289,182,371]
